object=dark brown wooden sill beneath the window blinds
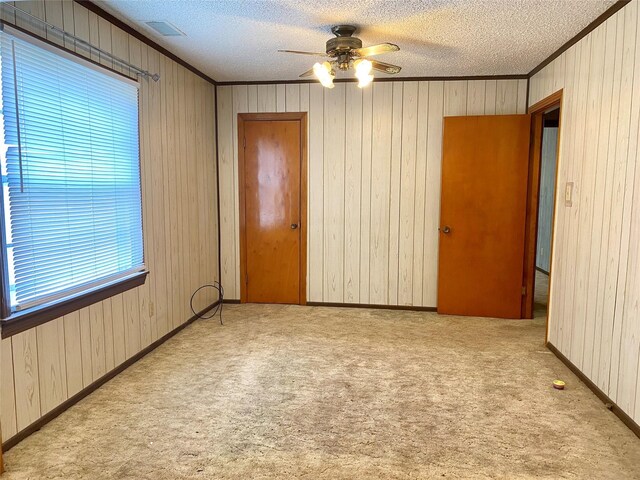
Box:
[1,271,149,338]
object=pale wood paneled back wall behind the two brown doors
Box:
[218,80,527,307]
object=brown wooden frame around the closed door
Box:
[237,112,308,305]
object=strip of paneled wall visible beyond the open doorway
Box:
[536,127,558,272]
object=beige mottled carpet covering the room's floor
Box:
[5,305,640,480]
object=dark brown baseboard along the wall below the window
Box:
[2,300,221,452]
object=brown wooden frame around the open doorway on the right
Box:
[522,89,563,336]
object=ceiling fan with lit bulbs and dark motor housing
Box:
[278,25,401,88]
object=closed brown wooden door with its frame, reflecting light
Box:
[238,114,306,304]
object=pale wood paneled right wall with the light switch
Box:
[529,1,640,423]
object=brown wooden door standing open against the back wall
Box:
[438,115,531,318]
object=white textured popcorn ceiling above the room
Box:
[96,0,615,81]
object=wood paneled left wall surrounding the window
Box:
[0,0,218,440]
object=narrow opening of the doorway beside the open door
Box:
[533,106,560,317]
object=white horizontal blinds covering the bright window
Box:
[0,27,144,311]
